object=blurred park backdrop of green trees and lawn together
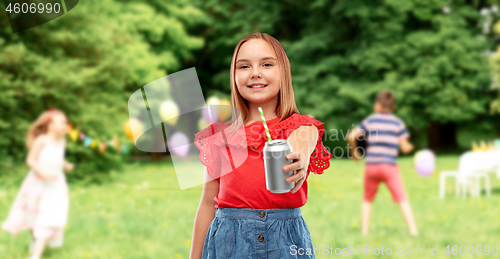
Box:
[0,0,500,258]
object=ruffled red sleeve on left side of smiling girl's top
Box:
[194,124,221,179]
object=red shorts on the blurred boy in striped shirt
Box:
[364,164,407,202]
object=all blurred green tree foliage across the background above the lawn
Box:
[0,0,498,175]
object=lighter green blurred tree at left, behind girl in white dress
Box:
[0,0,203,180]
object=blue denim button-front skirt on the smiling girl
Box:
[202,208,316,259]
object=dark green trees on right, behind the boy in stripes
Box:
[191,0,492,155]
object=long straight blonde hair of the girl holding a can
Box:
[231,32,299,132]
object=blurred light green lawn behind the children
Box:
[0,156,500,259]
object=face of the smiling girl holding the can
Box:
[235,39,281,103]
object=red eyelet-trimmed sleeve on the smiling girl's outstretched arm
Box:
[285,114,332,174]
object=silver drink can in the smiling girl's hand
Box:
[264,139,295,193]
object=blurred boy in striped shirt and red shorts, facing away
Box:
[348,90,418,236]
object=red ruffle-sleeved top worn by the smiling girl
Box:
[195,113,332,209]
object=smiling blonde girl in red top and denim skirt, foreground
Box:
[190,32,332,259]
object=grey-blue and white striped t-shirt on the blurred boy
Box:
[357,113,409,164]
